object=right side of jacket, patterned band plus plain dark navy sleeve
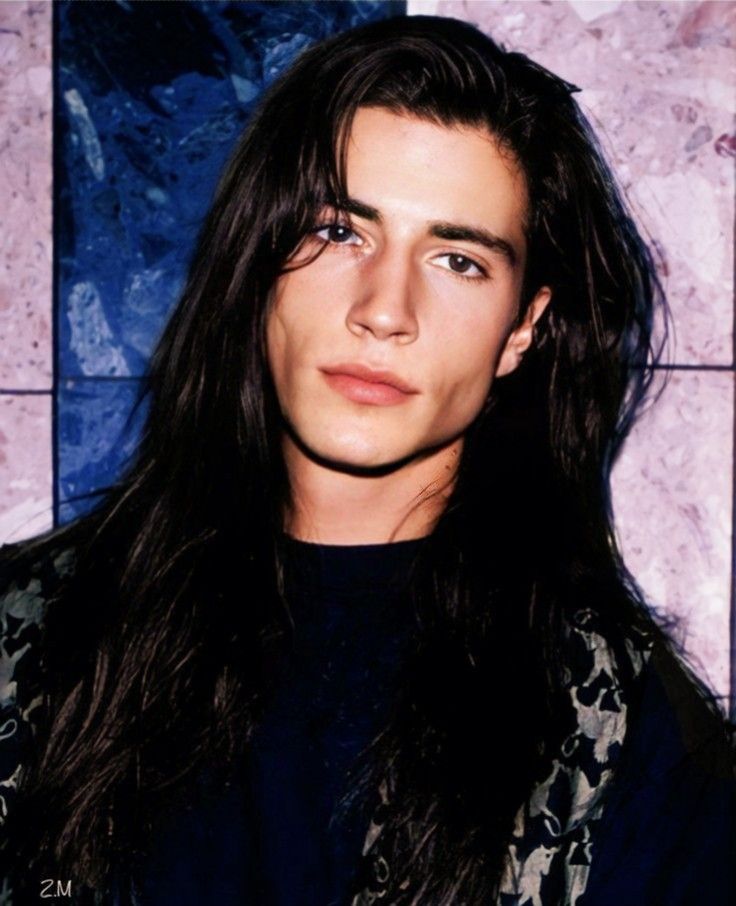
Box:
[502,609,736,906]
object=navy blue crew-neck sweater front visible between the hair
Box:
[129,539,421,906]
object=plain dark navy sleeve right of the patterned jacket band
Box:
[581,642,736,906]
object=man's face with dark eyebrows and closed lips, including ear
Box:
[267,108,549,468]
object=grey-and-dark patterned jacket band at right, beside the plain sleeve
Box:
[501,608,653,903]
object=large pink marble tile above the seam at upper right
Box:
[420,0,736,364]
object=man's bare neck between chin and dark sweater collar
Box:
[283,437,462,544]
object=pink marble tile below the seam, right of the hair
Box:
[613,371,734,695]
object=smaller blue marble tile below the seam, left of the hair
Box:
[56,378,145,523]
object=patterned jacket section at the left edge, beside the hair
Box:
[0,542,74,824]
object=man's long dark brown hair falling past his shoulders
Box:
[4,17,688,904]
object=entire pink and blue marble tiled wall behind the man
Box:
[0,0,736,708]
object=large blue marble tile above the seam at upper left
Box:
[55,0,405,378]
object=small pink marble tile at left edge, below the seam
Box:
[0,393,52,544]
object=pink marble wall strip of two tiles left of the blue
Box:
[0,3,53,541]
